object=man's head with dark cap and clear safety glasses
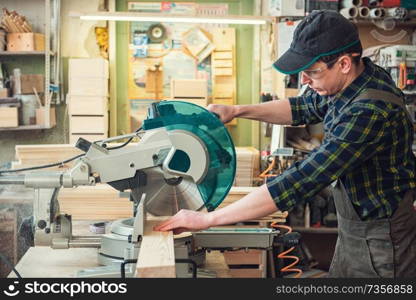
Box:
[274,10,362,95]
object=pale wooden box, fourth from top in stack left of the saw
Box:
[69,115,108,134]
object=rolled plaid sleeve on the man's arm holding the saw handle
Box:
[289,89,328,126]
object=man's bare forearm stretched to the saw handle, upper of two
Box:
[234,99,292,125]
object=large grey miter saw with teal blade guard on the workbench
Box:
[0,101,278,277]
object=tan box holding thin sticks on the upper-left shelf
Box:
[7,32,45,51]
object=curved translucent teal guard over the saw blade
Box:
[142,101,236,211]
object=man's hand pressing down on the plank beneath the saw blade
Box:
[154,209,211,234]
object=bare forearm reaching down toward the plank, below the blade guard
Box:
[209,184,277,226]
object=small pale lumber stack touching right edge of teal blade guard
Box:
[234,147,260,186]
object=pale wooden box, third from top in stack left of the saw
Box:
[67,95,108,115]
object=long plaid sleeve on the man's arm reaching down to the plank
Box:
[267,105,389,211]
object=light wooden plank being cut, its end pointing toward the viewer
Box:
[135,220,176,278]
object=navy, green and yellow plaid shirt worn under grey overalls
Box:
[267,58,416,220]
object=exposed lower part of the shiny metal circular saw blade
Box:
[141,167,204,216]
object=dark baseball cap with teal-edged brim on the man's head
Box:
[273,10,361,74]
